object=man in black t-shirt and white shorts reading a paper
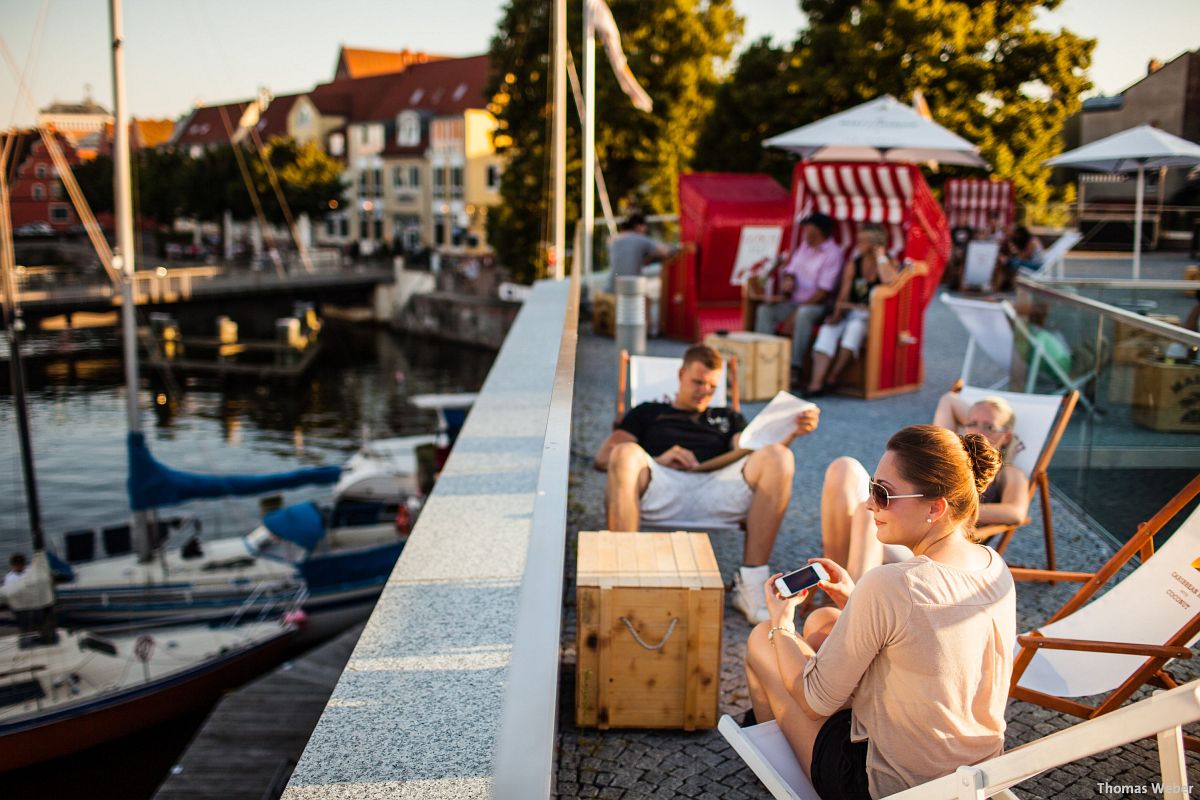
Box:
[595,345,820,624]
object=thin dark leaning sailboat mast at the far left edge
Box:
[0,140,46,553]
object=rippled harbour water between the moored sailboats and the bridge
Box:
[0,326,494,561]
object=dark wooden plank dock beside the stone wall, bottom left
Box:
[154,625,364,800]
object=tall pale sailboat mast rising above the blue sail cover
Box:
[108,0,152,561]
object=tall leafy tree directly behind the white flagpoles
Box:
[487,0,742,281]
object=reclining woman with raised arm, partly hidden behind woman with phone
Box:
[821,391,1030,581]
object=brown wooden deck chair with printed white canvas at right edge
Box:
[1009,476,1200,751]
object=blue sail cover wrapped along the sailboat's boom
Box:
[126,433,342,511]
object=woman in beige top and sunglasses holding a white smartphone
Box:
[746,425,1016,800]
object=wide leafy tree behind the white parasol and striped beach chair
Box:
[700,0,1094,220]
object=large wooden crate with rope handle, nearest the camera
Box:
[575,530,725,730]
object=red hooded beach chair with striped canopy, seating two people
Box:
[742,162,950,399]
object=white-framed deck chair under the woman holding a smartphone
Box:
[718,681,1200,800]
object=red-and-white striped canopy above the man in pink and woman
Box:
[791,162,950,293]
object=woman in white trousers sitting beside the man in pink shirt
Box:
[805,223,898,397]
